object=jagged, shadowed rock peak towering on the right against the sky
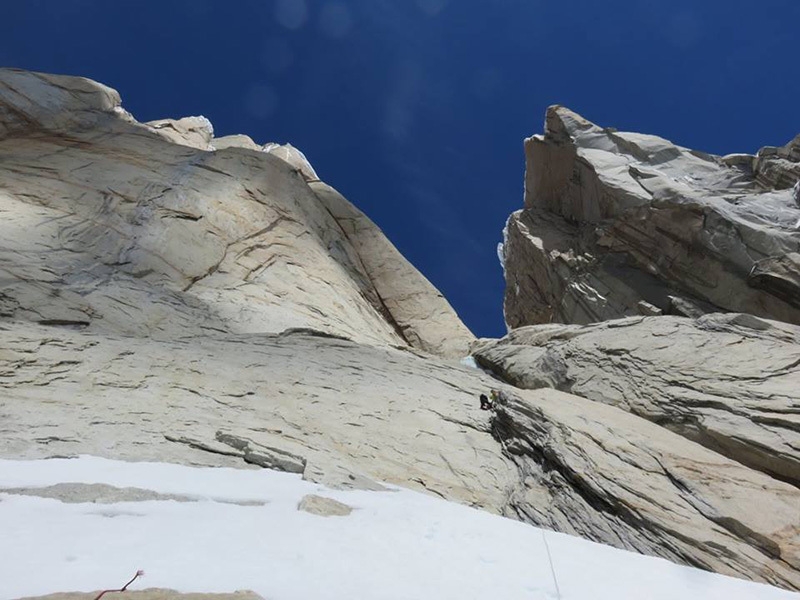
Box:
[501,107,800,328]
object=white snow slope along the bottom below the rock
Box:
[0,457,800,600]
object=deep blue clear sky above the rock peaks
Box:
[0,0,800,336]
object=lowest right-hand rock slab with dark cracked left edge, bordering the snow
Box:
[495,390,800,589]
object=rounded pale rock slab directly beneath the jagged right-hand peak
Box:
[476,314,800,488]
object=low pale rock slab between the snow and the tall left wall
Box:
[0,321,516,513]
